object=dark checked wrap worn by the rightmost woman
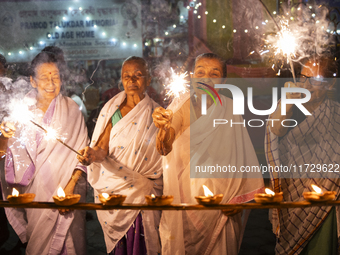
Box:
[265,99,340,254]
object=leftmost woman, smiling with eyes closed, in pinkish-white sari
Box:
[0,52,88,254]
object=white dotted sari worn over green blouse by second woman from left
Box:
[89,91,163,254]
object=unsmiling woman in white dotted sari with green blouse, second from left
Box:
[78,57,163,255]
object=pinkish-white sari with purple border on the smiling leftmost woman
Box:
[1,90,88,254]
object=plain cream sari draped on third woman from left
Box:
[160,94,263,254]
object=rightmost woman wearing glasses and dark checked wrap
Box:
[265,57,340,254]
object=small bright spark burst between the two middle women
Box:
[165,68,189,97]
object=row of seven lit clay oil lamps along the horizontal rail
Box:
[3,184,336,206]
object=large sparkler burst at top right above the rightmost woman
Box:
[259,0,335,82]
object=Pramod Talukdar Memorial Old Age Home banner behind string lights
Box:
[0,0,142,62]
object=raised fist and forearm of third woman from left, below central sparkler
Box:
[152,107,176,155]
